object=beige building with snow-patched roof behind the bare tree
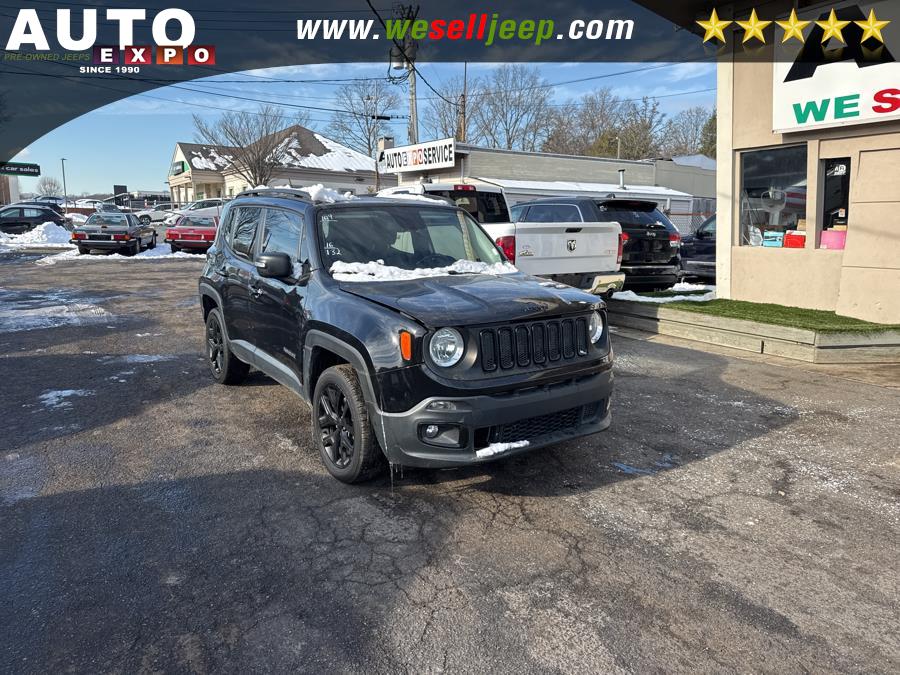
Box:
[166,125,375,204]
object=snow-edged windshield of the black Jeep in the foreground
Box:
[318,204,516,281]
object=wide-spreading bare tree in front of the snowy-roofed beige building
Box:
[194,105,305,186]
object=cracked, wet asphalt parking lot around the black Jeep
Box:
[0,253,900,672]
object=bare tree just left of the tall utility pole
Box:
[327,80,400,158]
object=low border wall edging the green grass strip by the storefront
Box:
[608,300,900,363]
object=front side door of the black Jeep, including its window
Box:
[250,207,306,382]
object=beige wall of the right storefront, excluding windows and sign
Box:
[716,48,900,323]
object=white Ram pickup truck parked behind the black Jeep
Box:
[378,179,625,295]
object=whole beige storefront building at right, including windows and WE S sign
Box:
[641,0,900,323]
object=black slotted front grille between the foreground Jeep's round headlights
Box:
[478,317,588,373]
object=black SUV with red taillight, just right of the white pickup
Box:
[597,199,681,289]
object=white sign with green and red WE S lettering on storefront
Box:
[772,5,900,133]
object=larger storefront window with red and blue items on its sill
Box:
[740,145,806,248]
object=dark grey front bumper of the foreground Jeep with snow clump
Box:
[370,368,613,468]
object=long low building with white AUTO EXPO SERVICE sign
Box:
[379,138,716,231]
